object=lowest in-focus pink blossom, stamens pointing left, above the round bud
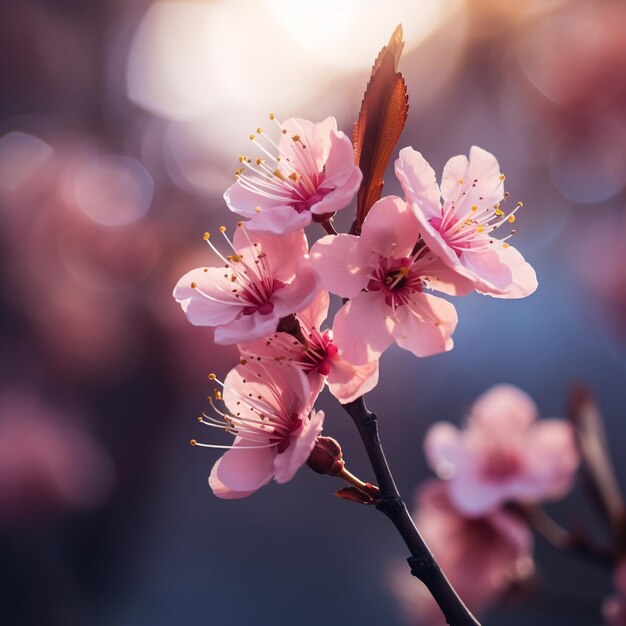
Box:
[192,361,324,499]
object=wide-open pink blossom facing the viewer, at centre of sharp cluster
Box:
[311,196,458,365]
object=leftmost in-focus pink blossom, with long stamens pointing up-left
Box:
[174,223,318,344]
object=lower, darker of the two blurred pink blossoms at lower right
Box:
[390,480,533,626]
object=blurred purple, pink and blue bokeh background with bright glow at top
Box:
[0,0,626,626]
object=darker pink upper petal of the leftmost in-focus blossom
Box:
[233,224,308,282]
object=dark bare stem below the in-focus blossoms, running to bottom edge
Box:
[342,397,480,626]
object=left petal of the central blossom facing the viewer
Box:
[311,235,369,298]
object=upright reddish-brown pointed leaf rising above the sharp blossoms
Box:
[350,25,409,235]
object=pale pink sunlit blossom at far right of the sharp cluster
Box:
[395,146,537,298]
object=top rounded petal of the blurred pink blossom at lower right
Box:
[470,385,537,437]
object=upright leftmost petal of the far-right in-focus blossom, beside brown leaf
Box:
[394,148,441,219]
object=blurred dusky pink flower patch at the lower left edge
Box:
[0,392,112,523]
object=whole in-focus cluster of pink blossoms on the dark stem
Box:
[174,114,537,498]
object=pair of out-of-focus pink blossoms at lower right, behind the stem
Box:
[391,385,576,626]
